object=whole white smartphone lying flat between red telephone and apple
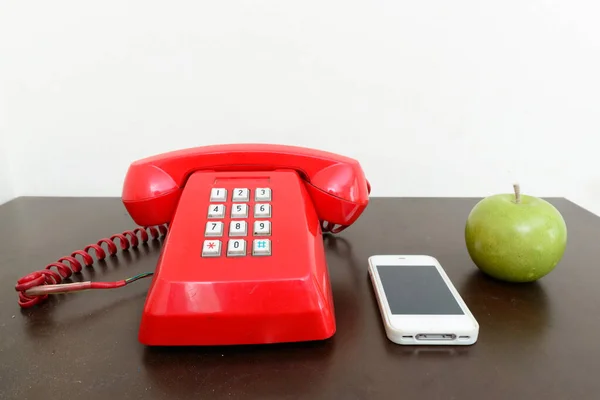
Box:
[369,255,479,345]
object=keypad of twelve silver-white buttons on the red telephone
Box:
[202,188,273,257]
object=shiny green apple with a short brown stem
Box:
[465,184,567,282]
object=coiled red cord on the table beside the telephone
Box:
[15,225,168,308]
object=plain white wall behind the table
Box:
[0,0,600,212]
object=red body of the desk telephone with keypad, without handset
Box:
[139,170,335,346]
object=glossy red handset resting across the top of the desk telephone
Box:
[123,144,371,232]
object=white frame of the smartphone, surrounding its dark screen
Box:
[368,255,479,345]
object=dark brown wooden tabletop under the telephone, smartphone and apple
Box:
[0,198,600,400]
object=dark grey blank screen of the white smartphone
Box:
[377,265,464,315]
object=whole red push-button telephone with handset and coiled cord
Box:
[17,144,371,345]
